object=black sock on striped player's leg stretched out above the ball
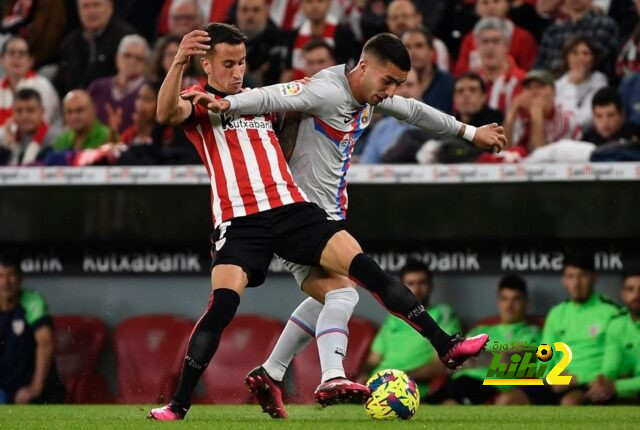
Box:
[349,254,450,356]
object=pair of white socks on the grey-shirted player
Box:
[262,287,359,382]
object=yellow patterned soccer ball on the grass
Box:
[364,369,420,420]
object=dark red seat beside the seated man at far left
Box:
[53,315,113,403]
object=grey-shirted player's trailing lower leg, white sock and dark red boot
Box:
[244,297,322,418]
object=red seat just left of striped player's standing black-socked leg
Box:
[113,315,193,403]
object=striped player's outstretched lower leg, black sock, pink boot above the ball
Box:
[320,231,489,369]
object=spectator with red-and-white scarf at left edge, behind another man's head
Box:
[0,36,62,126]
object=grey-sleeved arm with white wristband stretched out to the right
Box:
[379,95,507,152]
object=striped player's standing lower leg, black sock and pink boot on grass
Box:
[147,288,240,421]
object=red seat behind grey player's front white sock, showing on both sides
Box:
[292,317,376,403]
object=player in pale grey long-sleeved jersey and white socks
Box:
[188,34,505,417]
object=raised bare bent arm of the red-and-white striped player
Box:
[156,30,210,126]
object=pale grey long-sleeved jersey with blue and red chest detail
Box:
[226,64,462,220]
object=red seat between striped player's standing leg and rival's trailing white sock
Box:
[195,315,283,404]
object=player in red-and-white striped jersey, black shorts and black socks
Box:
[149,23,506,421]
